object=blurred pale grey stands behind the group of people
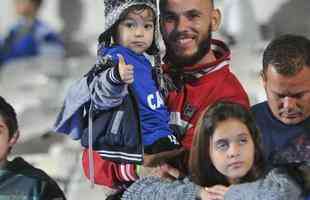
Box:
[0,0,310,200]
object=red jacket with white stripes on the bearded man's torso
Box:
[164,40,249,149]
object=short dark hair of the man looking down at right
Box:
[262,34,310,76]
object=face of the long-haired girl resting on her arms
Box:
[210,118,255,184]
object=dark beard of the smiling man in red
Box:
[164,25,212,67]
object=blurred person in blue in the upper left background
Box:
[0,0,64,65]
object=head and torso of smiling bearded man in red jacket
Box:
[160,0,249,152]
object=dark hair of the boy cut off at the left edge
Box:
[0,96,18,138]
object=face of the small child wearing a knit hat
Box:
[116,9,154,54]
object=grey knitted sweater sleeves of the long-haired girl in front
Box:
[122,169,304,200]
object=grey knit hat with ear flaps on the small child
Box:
[98,0,158,55]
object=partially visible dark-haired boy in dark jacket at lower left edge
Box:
[0,96,66,200]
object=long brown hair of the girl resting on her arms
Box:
[189,101,265,187]
